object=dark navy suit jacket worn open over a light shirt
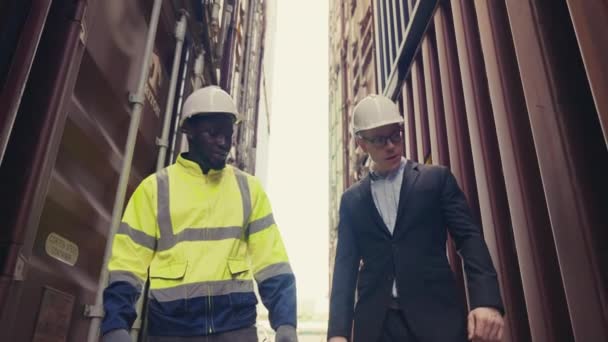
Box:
[328,160,504,342]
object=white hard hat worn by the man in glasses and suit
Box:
[352,95,403,134]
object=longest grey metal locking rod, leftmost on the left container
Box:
[85,0,163,342]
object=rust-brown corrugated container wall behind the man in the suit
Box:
[374,0,608,342]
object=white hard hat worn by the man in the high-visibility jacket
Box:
[180,86,243,126]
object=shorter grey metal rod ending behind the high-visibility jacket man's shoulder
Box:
[156,12,187,171]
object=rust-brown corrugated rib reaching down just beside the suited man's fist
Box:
[451,7,529,341]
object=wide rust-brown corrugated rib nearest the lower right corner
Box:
[507,1,608,341]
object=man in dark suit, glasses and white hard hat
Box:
[328,95,504,342]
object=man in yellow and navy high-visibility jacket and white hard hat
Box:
[101,86,297,342]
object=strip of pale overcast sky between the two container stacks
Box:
[267,0,329,307]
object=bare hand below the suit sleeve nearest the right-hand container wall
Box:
[468,308,505,342]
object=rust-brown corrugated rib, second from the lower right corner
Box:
[475,1,573,341]
